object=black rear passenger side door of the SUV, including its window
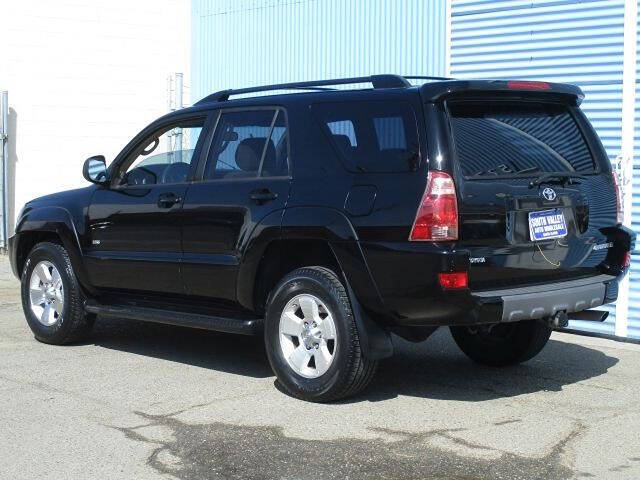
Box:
[182,108,290,303]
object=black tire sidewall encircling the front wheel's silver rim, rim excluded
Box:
[21,244,75,343]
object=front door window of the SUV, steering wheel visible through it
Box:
[119,118,205,185]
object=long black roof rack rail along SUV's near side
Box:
[195,75,411,105]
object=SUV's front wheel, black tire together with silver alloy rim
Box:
[20,242,95,345]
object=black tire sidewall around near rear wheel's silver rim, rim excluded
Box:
[265,275,353,398]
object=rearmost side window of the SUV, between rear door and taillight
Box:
[313,101,420,172]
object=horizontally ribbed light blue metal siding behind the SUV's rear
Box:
[450,0,624,335]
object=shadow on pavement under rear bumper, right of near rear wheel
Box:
[356,328,619,402]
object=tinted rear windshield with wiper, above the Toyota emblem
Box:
[448,102,594,176]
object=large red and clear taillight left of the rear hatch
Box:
[409,171,458,242]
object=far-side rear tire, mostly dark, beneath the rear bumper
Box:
[450,320,551,367]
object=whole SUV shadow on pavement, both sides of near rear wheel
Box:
[82,318,618,403]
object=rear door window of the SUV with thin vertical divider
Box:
[204,110,289,180]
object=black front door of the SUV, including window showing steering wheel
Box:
[86,116,206,294]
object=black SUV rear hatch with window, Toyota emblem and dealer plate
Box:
[445,92,617,290]
